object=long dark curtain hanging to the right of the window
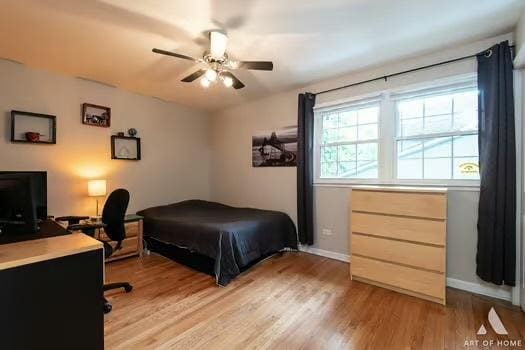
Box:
[476,42,516,286]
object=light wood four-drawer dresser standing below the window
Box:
[350,186,447,305]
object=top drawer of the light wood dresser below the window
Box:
[351,189,447,219]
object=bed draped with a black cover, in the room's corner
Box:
[137,200,297,286]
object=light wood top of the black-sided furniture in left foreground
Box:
[0,233,103,270]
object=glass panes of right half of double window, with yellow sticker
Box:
[396,88,479,180]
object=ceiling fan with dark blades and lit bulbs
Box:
[152,31,273,89]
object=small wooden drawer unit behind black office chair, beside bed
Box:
[96,215,143,262]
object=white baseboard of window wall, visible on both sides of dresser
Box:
[299,245,512,301]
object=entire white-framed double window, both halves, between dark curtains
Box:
[315,77,479,185]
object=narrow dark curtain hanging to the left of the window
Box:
[297,92,315,245]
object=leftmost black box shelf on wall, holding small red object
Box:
[11,111,56,144]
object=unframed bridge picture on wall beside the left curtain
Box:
[252,126,297,167]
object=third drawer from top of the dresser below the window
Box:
[352,234,445,272]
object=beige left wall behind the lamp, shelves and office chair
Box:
[0,60,209,215]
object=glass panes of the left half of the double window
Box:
[320,104,379,179]
